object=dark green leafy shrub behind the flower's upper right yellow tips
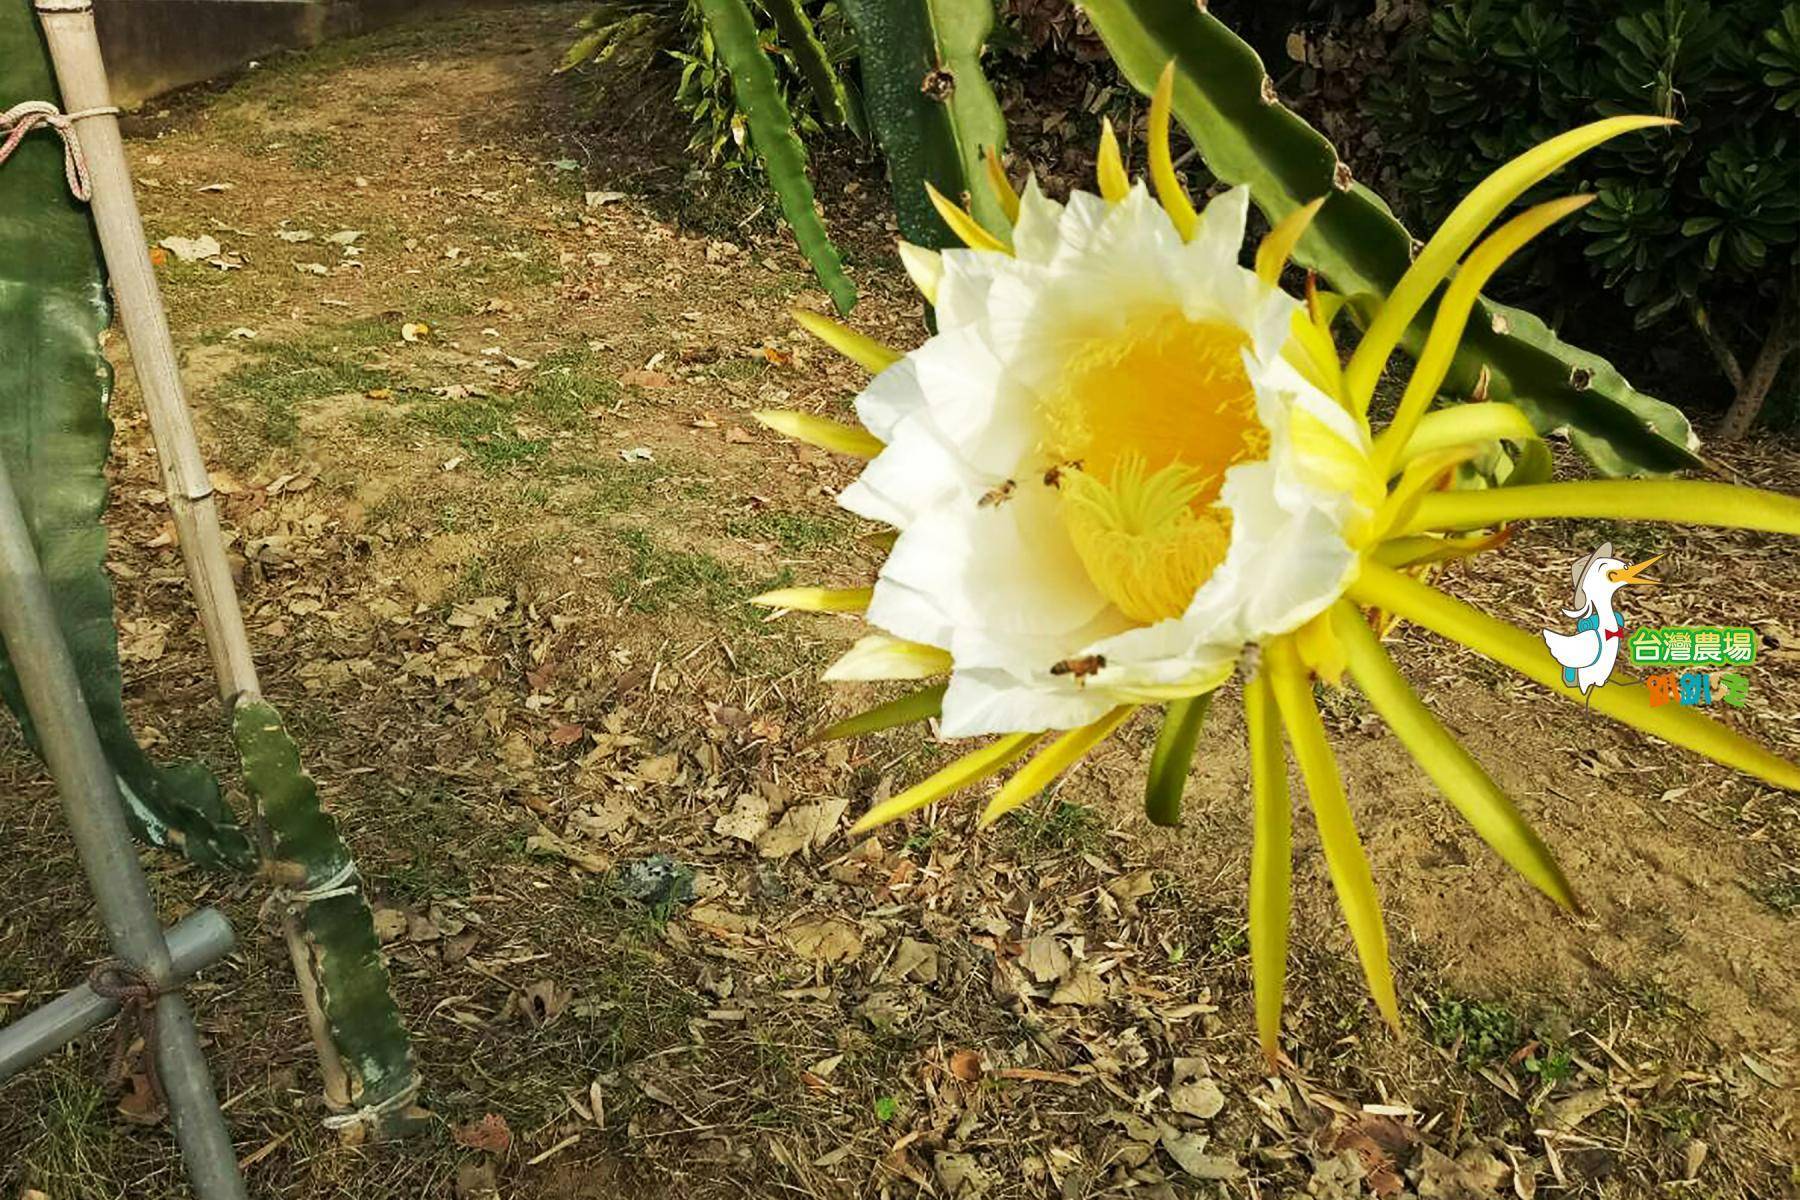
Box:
[1368,0,1800,437]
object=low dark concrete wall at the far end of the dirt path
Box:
[94,0,448,108]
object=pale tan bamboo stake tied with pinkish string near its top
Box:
[36,0,351,1110]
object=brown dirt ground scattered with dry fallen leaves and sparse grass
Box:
[0,5,1800,1200]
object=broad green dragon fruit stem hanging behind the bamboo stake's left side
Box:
[0,4,256,869]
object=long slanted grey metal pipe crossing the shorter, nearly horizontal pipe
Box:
[0,457,247,1200]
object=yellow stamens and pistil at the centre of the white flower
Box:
[1044,309,1269,622]
